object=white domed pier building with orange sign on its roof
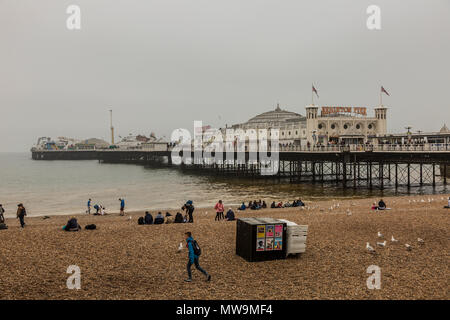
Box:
[231,104,387,146]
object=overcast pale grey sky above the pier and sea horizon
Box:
[0,0,450,151]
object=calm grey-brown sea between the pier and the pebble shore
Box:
[0,153,445,216]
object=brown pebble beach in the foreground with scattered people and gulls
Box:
[0,194,450,300]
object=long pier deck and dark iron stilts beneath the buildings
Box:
[32,144,450,189]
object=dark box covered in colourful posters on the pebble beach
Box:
[236,218,286,262]
